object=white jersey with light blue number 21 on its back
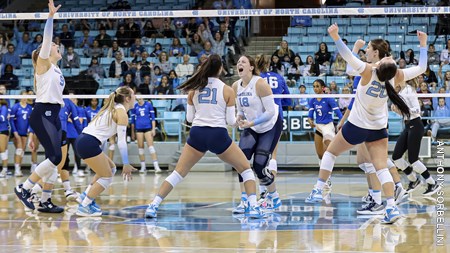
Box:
[192,77,227,128]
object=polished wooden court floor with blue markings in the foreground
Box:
[0,171,450,253]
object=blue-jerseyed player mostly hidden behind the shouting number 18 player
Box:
[255,55,292,206]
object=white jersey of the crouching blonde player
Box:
[83,104,125,144]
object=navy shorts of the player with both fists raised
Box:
[342,121,388,145]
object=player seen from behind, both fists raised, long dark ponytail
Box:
[308,24,427,223]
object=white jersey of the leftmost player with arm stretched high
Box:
[35,64,66,105]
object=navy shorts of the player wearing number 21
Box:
[187,126,232,154]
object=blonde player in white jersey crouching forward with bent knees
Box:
[74,86,136,216]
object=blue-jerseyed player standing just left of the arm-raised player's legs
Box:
[10,91,33,177]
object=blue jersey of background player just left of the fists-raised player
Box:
[308,98,342,124]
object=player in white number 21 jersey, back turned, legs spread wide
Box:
[145,54,266,218]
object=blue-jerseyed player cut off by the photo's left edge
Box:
[0,85,10,178]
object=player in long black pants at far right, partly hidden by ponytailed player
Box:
[391,84,441,196]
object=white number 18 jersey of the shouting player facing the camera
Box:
[237,76,279,133]
